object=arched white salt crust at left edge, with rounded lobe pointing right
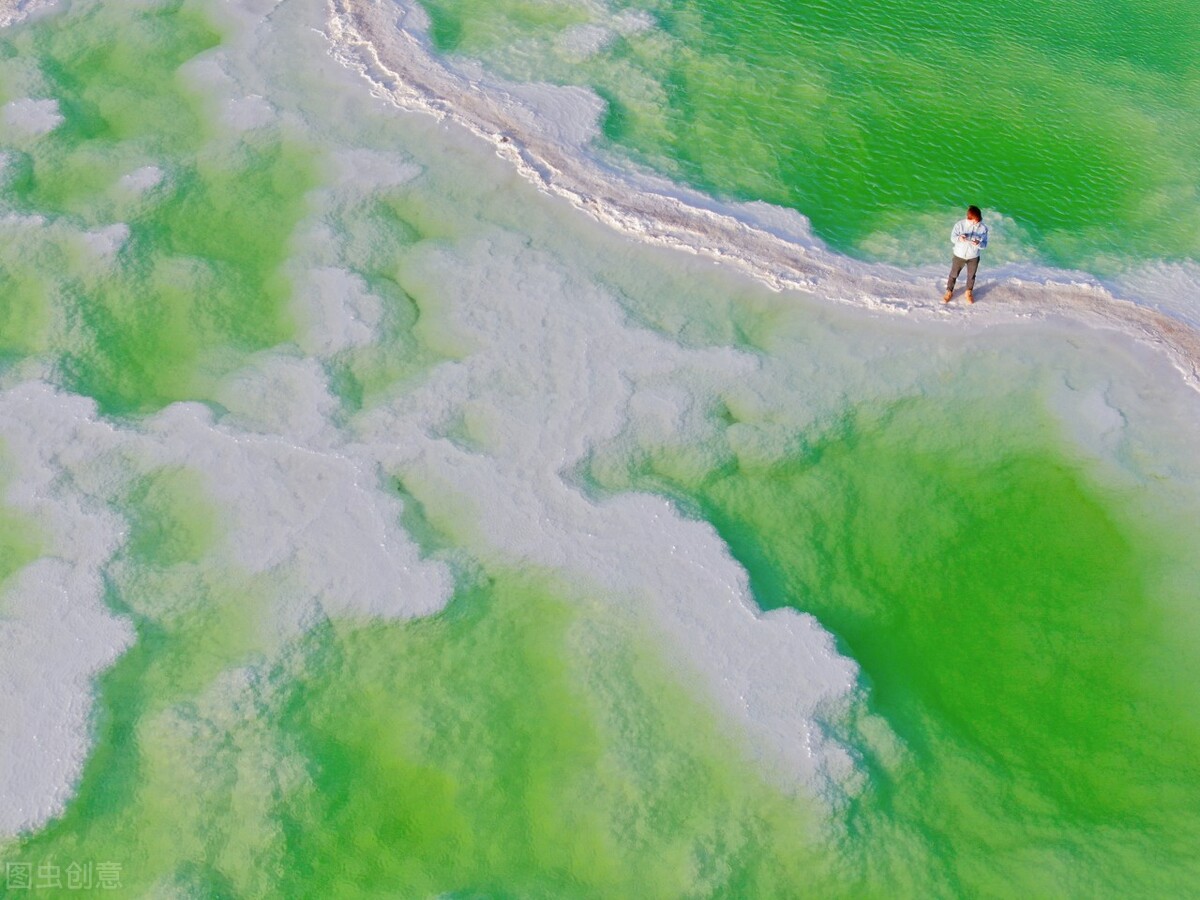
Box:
[0,376,452,835]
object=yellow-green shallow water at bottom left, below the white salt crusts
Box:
[6,574,844,898]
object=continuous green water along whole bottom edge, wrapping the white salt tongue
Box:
[11,398,1200,898]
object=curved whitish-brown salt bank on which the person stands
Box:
[328,0,1200,390]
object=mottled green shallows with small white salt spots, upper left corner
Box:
[0,2,319,414]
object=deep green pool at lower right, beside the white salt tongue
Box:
[600,401,1200,896]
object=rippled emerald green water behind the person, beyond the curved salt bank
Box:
[422,0,1200,272]
